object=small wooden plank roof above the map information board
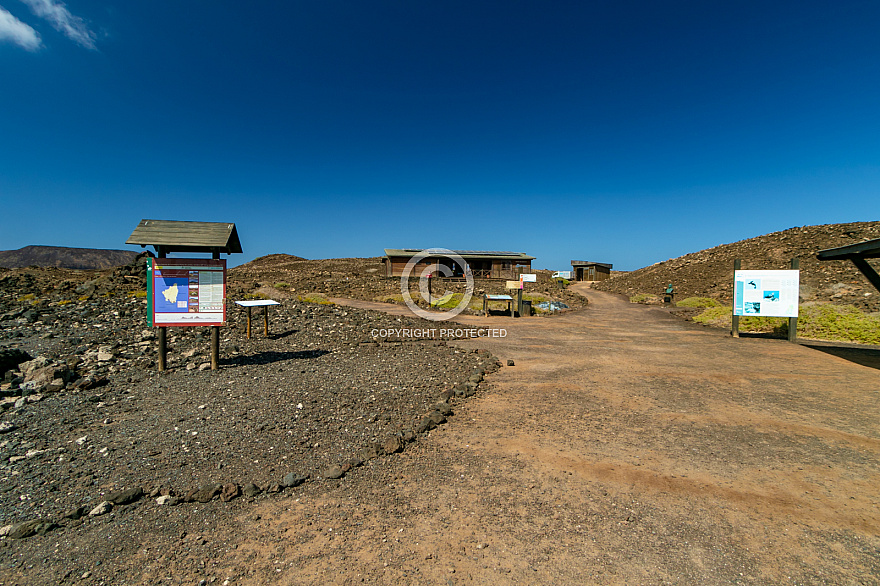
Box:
[125,220,241,254]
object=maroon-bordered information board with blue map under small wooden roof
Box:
[147,258,226,328]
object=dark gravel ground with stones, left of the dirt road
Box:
[0,288,499,584]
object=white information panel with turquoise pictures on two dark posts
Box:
[733,271,800,317]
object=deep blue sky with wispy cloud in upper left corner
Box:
[0,0,880,270]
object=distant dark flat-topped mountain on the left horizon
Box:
[0,246,137,269]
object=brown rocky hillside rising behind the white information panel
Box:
[595,222,880,311]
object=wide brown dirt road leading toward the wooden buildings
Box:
[229,291,880,584]
